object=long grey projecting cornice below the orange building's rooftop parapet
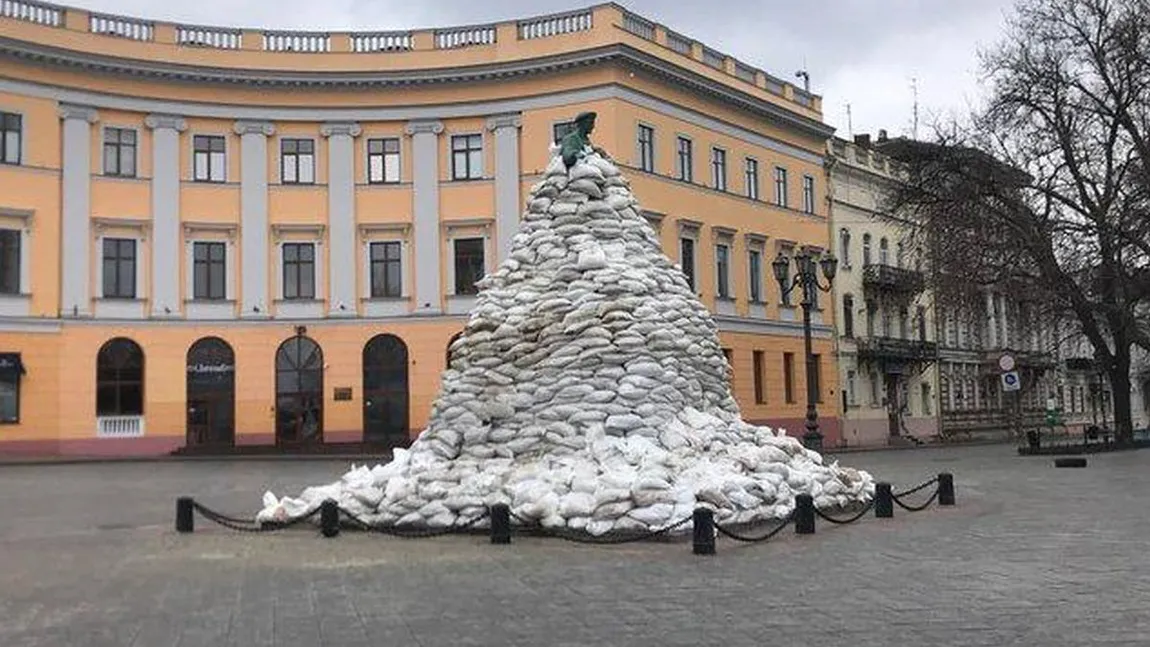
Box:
[0,38,835,140]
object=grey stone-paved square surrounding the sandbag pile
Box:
[0,446,1150,647]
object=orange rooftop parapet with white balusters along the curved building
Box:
[0,0,821,114]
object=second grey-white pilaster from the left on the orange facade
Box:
[144,115,191,317]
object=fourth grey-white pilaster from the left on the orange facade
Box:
[320,123,362,317]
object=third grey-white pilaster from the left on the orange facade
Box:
[236,121,276,318]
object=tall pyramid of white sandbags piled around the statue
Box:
[258,146,874,536]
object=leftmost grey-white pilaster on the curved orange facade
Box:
[59,105,99,317]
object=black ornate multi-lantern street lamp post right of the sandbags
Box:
[772,252,838,450]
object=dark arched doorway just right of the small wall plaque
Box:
[363,334,408,445]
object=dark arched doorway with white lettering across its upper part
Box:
[186,337,236,447]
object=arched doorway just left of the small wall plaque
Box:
[276,334,323,445]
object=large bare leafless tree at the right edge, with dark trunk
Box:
[883,0,1150,439]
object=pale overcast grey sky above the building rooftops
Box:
[63,0,1013,137]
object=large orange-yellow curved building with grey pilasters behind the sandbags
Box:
[0,0,837,455]
